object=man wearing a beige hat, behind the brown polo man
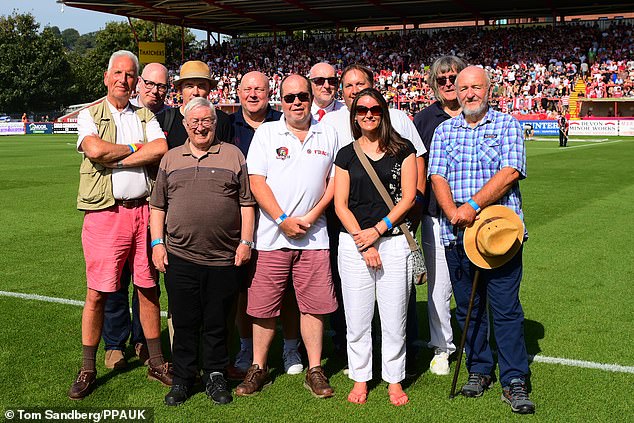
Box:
[156,60,231,150]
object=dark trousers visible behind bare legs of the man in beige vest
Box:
[101,264,161,350]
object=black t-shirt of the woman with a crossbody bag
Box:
[335,141,416,236]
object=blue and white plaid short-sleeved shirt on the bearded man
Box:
[428,108,528,246]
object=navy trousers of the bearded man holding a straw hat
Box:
[445,245,528,386]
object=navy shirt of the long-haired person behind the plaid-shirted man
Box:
[414,101,451,217]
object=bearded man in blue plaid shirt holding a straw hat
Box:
[429,66,535,414]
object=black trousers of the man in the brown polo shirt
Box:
[165,254,238,386]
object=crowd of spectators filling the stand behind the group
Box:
[160,21,634,114]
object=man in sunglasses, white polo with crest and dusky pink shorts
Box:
[236,75,338,398]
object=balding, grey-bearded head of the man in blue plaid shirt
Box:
[456,66,491,123]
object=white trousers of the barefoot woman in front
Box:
[338,233,412,383]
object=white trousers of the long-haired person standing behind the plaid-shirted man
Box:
[421,215,456,354]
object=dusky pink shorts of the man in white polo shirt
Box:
[247,248,337,319]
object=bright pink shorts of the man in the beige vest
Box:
[81,204,157,292]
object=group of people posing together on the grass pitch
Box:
[69,51,534,413]
